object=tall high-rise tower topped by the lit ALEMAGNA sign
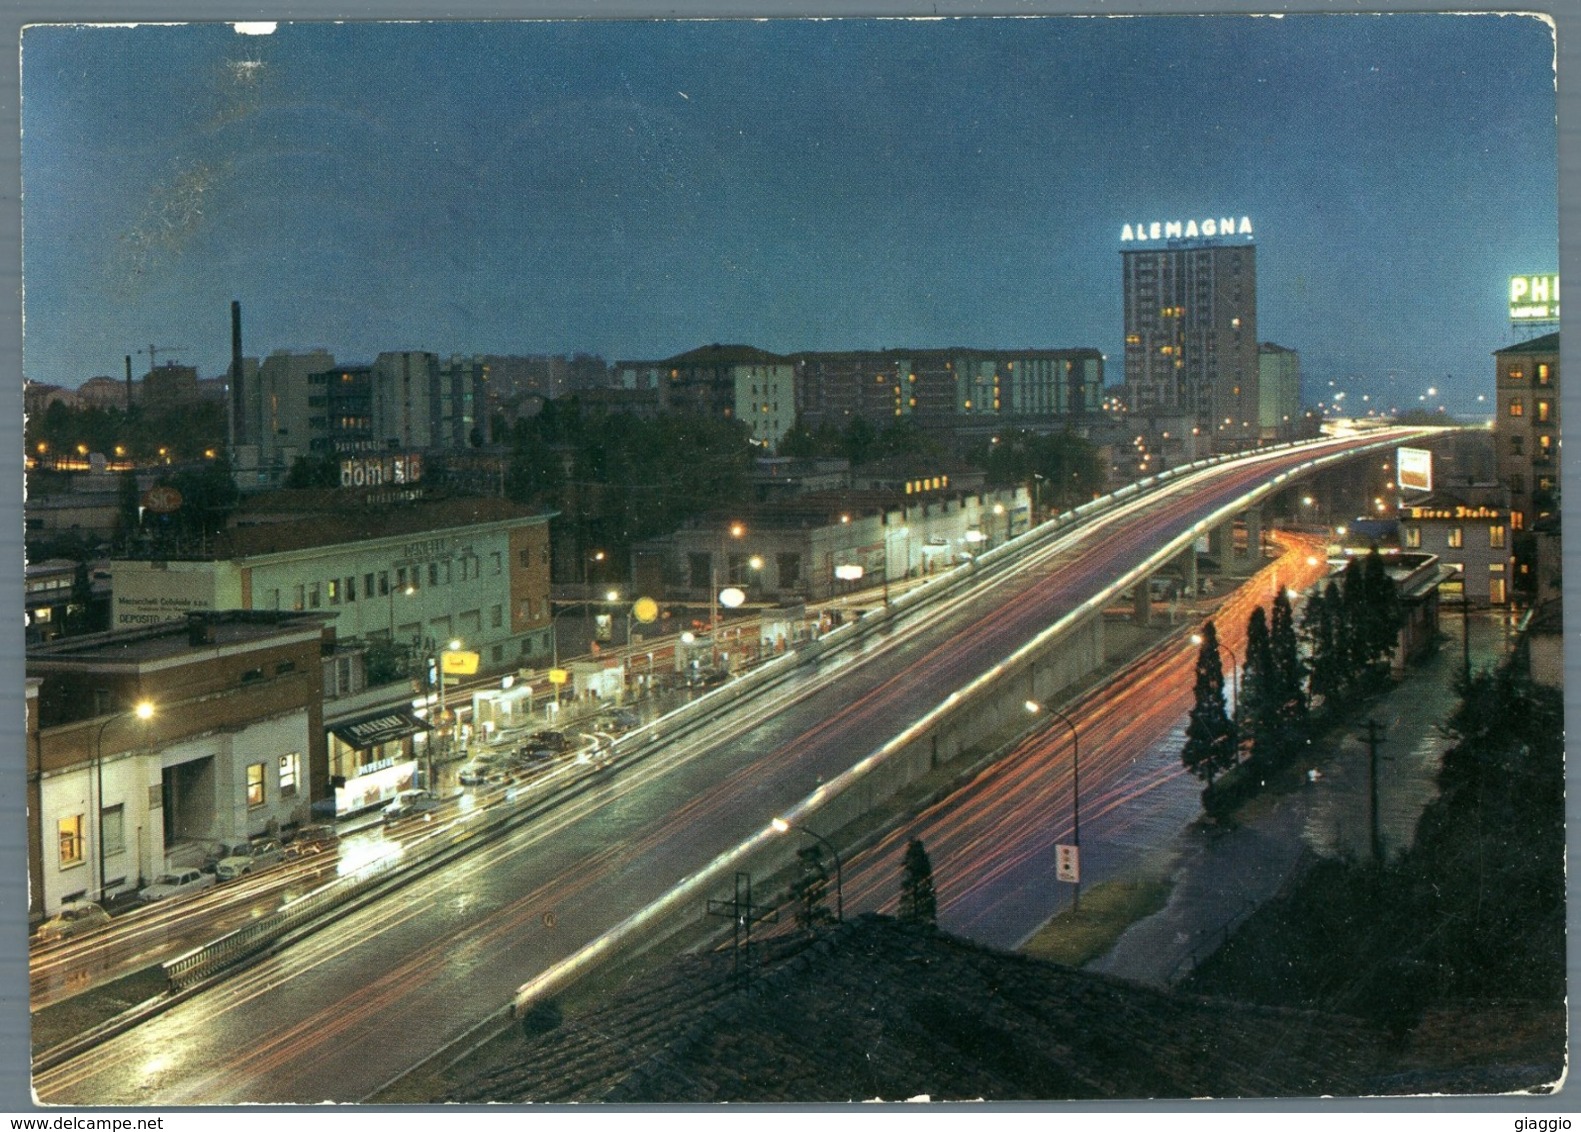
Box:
[1121,217,1258,447]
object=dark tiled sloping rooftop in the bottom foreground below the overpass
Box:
[447,914,1383,1104]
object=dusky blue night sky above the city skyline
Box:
[22,14,1559,413]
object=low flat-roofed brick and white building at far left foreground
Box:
[27,612,329,917]
